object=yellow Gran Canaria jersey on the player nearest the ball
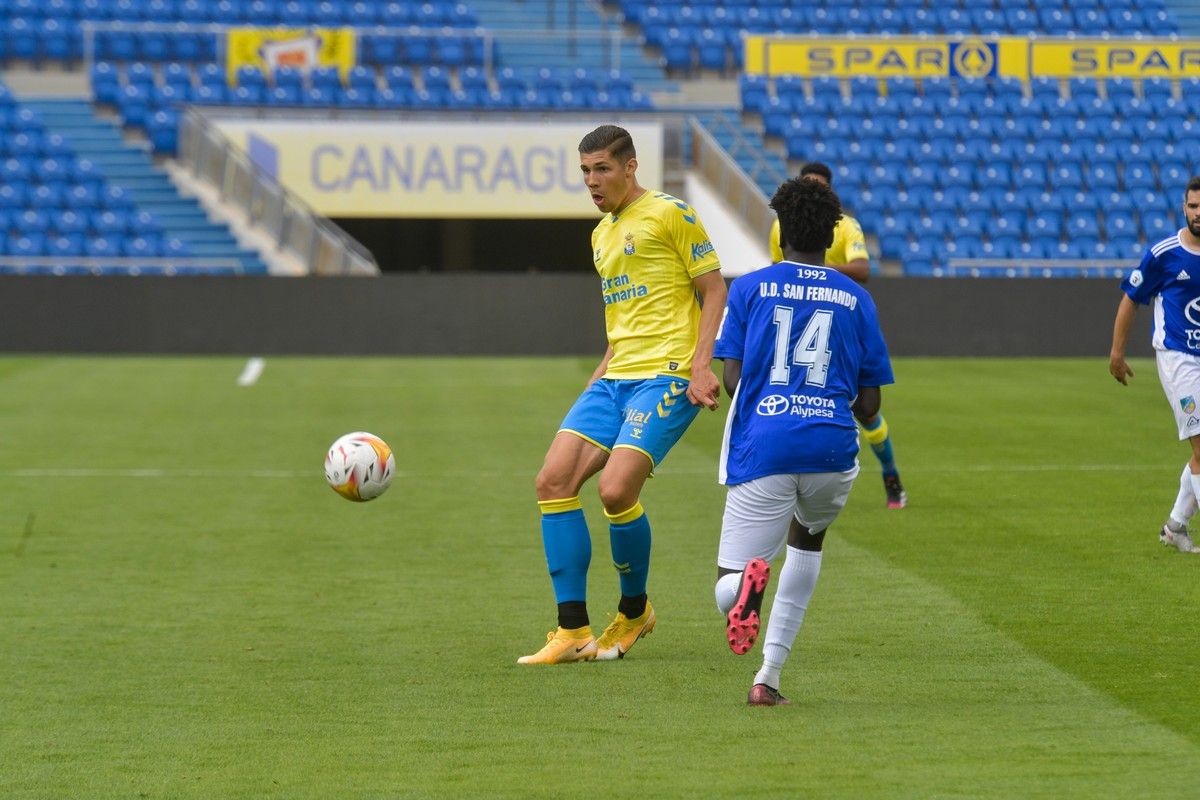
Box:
[592,190,721,379]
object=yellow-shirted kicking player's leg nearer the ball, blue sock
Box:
[517,381,619,664]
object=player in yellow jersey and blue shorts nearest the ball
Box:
[517,125,726,664]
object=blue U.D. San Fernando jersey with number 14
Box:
[714,261,893,486]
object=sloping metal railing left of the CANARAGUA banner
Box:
[179,108,379,275]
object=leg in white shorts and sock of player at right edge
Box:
[1156,350,1200,553]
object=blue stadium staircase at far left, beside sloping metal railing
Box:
[24,100,268,275]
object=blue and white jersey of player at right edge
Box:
[1121,233,1200,355]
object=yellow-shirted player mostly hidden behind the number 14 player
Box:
[770,161,908,509]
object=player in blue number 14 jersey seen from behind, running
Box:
[714,179,893,705]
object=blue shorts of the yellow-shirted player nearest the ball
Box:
[558,375,700,467]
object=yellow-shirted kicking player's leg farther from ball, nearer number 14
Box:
[596,377,700,661]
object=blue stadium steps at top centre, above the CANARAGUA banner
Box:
[470,0,678,91]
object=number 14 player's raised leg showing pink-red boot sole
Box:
[714,475,796,655]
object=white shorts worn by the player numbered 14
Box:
[716,465,858,570]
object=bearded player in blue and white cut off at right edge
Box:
[1109,176,1200,553]
